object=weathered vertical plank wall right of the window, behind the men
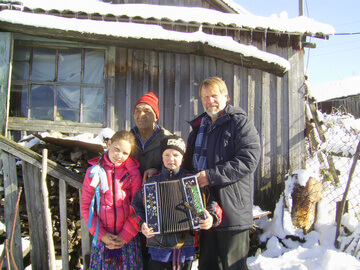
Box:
[113,46,305,209]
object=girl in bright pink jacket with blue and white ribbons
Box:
[81,131,142,269]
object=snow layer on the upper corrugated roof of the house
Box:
[3,0,335,36]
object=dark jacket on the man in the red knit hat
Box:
[131,127,172,176]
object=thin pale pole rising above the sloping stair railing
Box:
[41,148,56,270]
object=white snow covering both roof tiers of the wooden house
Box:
[0,0,335,76]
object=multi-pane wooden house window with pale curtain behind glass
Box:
[10,42,105,124]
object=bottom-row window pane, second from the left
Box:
[30,85,54,120]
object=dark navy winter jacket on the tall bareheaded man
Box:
[184,105,261,231]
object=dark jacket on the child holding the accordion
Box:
[131,166,221,249]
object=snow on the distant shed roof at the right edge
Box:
[309,75,360,102]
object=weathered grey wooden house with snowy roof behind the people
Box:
[0,0,333,214]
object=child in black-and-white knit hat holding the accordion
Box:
[131,135,221,270]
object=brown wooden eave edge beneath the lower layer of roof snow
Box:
[1,21,288,77]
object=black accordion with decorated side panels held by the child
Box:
[144,175,206,234]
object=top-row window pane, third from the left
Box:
[58,49,81,83]
